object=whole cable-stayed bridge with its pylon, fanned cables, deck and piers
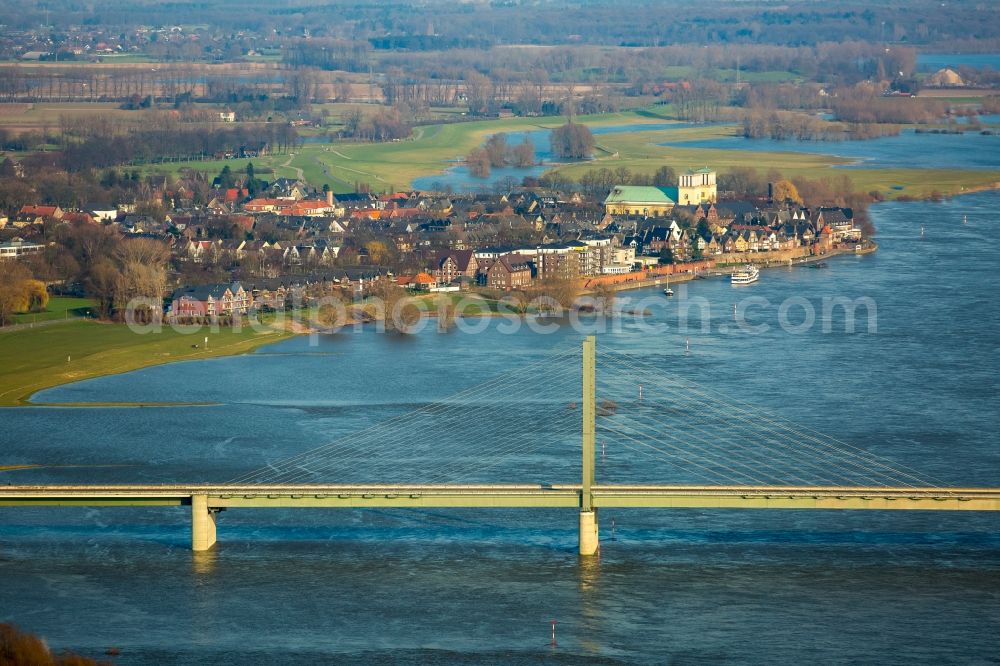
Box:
[0,337,1000,555]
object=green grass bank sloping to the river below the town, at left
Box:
[0,321,291,406]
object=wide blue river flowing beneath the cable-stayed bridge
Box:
[0,193,1000,664]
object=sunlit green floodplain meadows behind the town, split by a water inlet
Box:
[135,107,1000,199]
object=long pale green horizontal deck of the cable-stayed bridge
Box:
[0,484,1000,511]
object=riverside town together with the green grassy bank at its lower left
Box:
[0,167,872,404]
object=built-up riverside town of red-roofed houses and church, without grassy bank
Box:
[0,167,867,323]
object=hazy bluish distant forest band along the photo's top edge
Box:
[0,0,1000,53]
